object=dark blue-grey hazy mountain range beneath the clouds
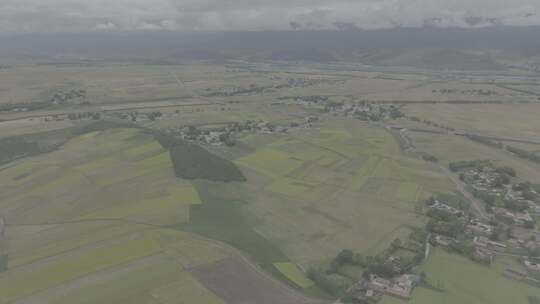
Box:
[0,26,540,70]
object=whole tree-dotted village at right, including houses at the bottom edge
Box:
[336,161,540,303]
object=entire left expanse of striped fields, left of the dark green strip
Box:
[0,129,312,304]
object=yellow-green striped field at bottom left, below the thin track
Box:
[0,228,236,303]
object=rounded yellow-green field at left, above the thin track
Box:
[0,129,200,224]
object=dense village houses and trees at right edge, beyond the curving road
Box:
[426,161,540,286]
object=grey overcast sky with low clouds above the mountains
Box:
[0,0,540,33]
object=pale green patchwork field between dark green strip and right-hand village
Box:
[235,120,452,266]
